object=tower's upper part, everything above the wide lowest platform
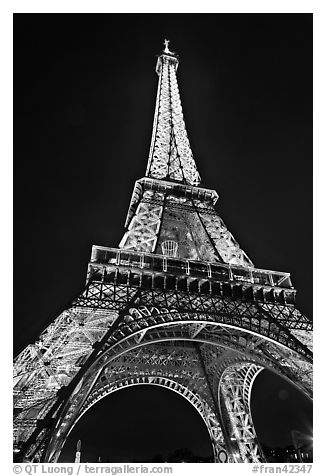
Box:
[119,40,253,267]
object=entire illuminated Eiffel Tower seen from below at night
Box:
[14,40,312,463]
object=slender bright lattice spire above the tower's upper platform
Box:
[146,39,200,186]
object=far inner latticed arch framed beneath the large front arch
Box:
[47,343,226,461]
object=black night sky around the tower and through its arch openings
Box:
[14,14,312,461]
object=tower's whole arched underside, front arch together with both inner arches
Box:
[37,308,311,462]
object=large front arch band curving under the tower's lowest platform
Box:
[21,312,310,462]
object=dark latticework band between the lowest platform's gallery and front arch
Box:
[75,282,312,359]
